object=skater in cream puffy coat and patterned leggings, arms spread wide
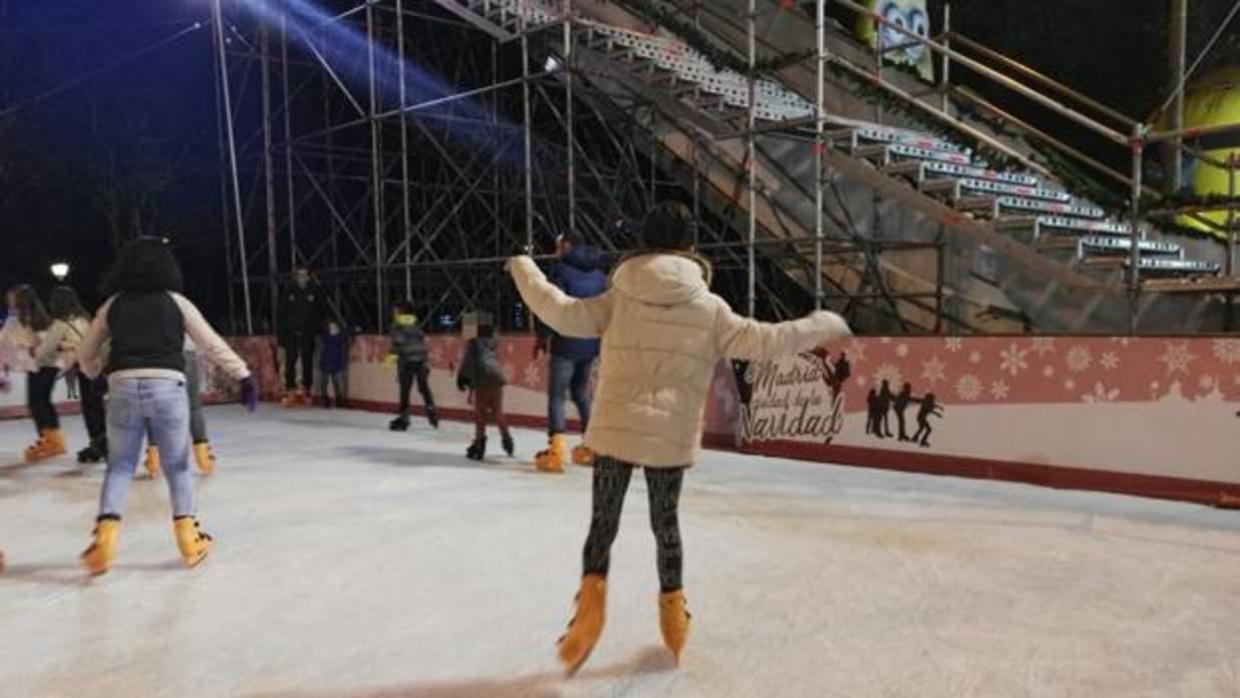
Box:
[510,203,849,674]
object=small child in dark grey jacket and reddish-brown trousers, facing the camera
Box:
[456,312,513,460]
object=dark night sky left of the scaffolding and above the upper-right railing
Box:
[0,0,1240,317]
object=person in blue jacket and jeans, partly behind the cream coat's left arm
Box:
[534,232,608,472]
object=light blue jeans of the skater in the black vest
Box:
[99,378,193,517]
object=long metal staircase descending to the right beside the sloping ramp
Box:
[436,0,1221,332]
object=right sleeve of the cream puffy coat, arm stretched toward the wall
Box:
[715,299,852,361]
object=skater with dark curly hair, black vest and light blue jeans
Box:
[78,237,258,574]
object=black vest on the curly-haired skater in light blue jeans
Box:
[105,291,185,374]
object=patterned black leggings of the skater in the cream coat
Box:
[582,456,684,593]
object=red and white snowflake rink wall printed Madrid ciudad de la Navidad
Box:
[0,336,1240,506]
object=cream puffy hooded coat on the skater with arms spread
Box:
[508,254,849,467]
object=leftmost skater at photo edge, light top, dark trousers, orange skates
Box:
[0,286,64,462]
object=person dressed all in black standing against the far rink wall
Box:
[279,267,324,407]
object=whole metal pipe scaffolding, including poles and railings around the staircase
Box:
[212,0,1240,332]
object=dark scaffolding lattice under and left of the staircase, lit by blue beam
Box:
[212,0,944,332]
